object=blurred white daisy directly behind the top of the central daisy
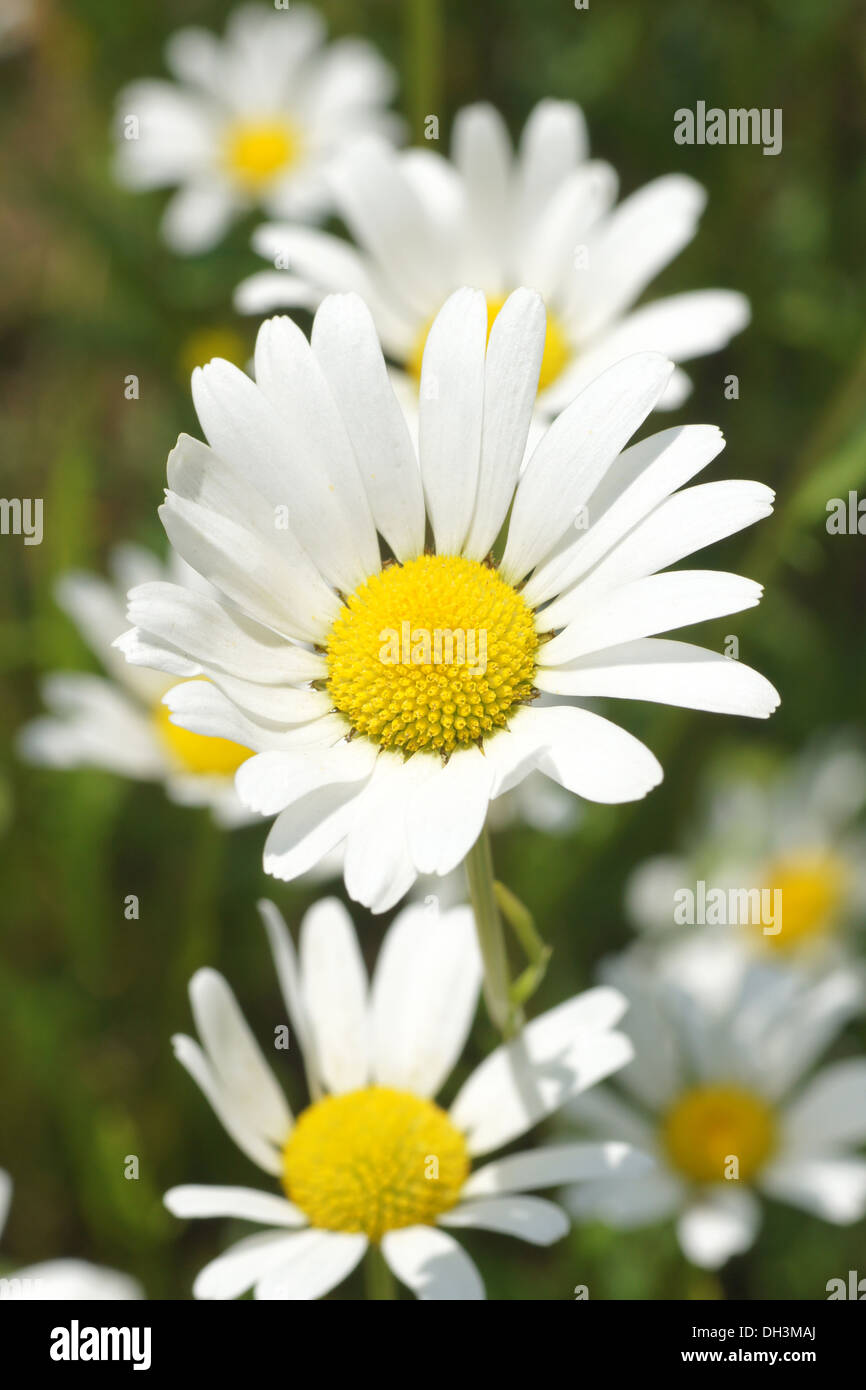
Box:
[236,100,749,414]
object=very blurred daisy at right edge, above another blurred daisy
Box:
[626,734,866,969]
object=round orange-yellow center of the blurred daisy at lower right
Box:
[662,1086,776,1183]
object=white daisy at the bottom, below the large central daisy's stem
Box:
[165,898,648,1300]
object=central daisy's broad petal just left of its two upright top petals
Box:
[313,295,425,562]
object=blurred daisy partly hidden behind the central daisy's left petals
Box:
[18,545,257,827]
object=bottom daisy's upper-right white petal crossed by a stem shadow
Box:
[450,987,631,1154]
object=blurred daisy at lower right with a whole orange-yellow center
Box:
[567,942,866,1269]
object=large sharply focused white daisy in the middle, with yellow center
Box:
[118,289,778,912]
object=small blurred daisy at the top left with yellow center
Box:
[115,4,399,254]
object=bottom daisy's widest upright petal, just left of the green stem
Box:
[373,906,481,1095]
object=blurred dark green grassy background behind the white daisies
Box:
[0,0,866,1300]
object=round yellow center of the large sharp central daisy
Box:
[327,555,538,756]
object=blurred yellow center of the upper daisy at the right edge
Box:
[762,849,849,951]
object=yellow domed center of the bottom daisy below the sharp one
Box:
[282,1086,470,1241]
